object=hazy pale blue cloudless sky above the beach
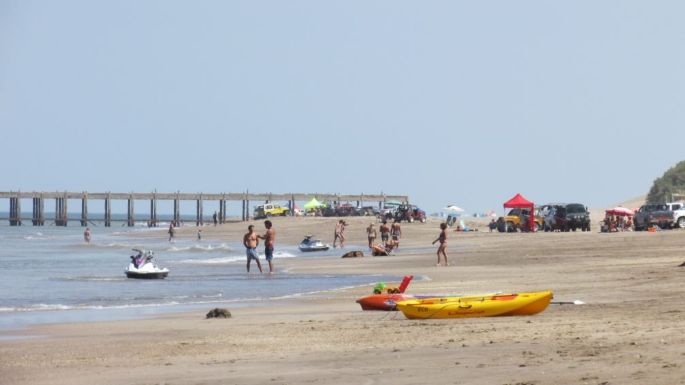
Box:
[0,0,685,211]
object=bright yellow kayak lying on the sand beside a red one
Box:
[397,291,552,319]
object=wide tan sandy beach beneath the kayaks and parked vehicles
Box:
[0,218,685,385]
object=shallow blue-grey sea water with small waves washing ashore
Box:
[0,222,397,332]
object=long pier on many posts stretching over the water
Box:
[0,191,409,227]
